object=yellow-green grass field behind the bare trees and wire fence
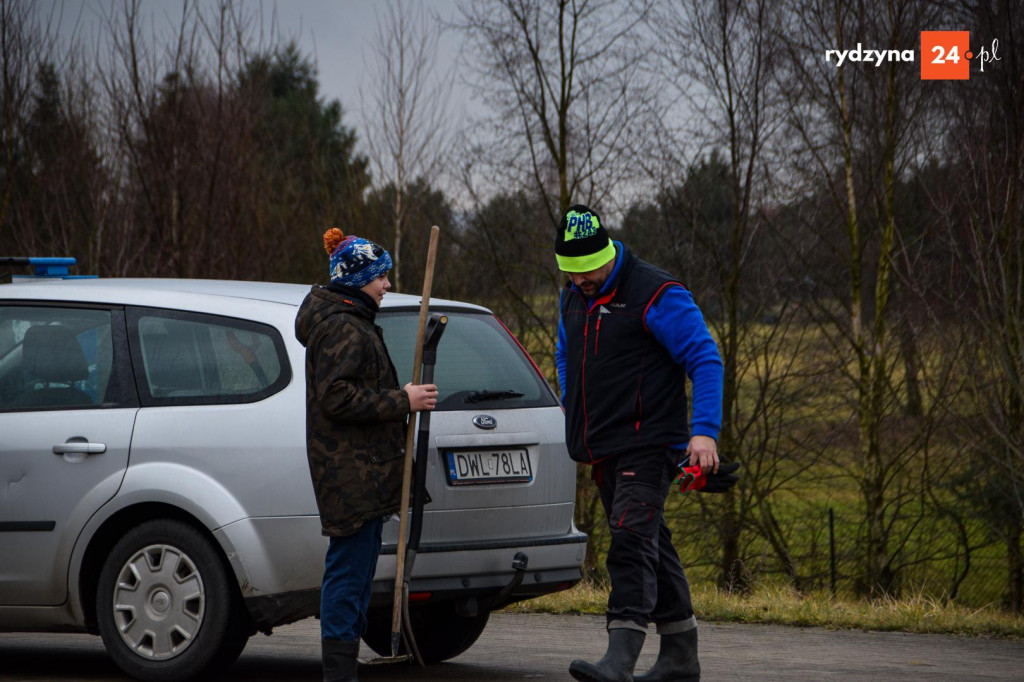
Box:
[505,308,1024,623]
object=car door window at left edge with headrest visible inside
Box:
[0,305,134,411]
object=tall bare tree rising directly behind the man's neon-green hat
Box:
[458,0,657,372]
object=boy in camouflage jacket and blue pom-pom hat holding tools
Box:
[295,228,437,682]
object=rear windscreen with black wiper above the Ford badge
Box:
[377,310,558,410]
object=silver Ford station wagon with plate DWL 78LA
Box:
[0,264,586,680]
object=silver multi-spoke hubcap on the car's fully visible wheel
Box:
[113,545,206,660]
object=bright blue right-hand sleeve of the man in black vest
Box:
[644,286,723,439]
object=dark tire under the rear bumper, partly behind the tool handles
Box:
[362,602,490,664]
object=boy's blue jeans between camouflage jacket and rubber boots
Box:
[321,518,384,642]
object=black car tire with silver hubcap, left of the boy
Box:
[96,519,252,682]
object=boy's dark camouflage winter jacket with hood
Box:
[295,286,410,536]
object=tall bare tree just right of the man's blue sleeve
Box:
[652,0,813,588]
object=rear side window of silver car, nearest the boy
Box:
[129,309,291,404]
